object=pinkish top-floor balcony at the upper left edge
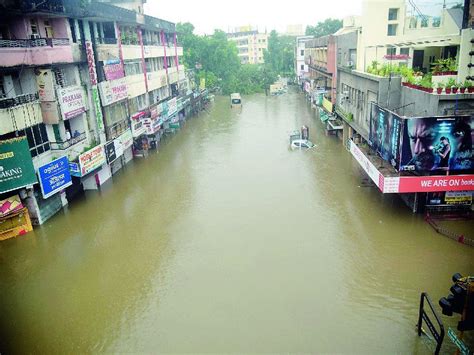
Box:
[0,38,74,67]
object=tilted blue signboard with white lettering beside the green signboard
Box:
[38,157,72,198]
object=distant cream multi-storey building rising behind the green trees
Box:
[227,26,268,64]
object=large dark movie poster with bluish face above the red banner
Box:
[400,116,474,172]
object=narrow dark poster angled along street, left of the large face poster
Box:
[369,104,403,170]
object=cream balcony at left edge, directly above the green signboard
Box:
[0,94,43,135]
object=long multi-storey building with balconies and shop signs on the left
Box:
[0,0,193,231]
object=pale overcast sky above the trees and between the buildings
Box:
[145,0,361,34]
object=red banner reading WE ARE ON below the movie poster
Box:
[398,175,474,193]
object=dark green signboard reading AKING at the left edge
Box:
[0,137,37,193]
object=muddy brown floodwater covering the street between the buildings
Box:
[0,92,474,353]
